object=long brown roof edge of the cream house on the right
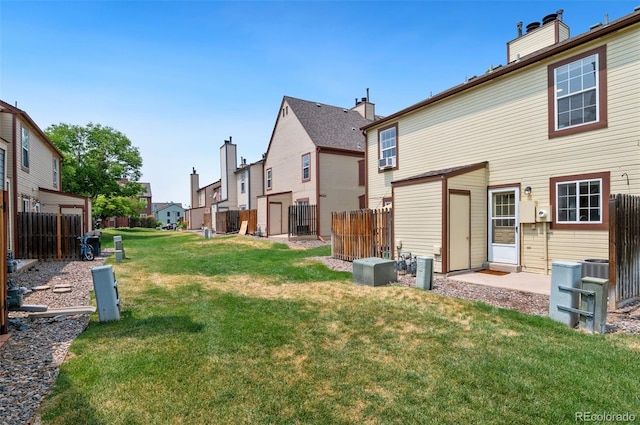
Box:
[362,10,640,131]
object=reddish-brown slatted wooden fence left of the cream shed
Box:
[331,209,393,261]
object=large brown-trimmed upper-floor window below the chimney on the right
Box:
[548,46,607,137]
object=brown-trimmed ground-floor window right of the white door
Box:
[550,172,610,230]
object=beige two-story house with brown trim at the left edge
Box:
[0,97,92,255]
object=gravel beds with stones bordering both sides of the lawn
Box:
[0,235,640,425]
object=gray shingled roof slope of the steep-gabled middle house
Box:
[283,96,373,152]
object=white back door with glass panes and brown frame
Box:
[488,188,520,264]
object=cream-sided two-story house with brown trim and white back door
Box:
[362,11,640,273]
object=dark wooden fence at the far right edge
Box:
[609,194,640,306]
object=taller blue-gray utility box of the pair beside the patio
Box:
[549,261,582,328]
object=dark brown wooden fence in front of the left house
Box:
[14,213,82,261]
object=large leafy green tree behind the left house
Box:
[45,123,144,197]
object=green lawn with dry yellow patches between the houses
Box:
[40,229,640,425]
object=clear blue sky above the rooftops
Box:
[0,0,640,207]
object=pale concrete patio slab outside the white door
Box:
[447,272,551,295]
